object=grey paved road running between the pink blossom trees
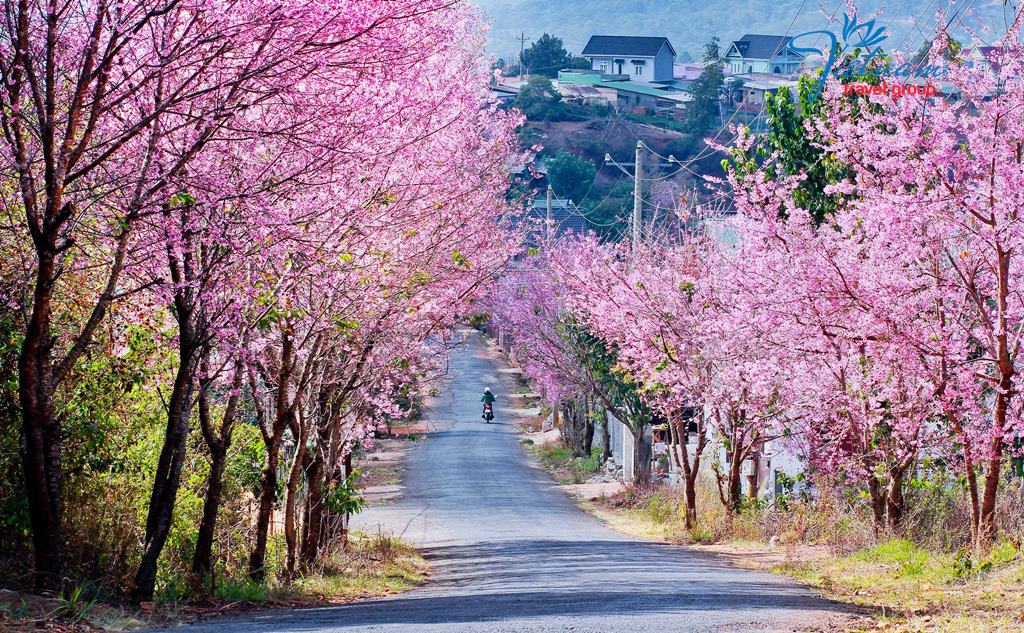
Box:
[165,333,840,633]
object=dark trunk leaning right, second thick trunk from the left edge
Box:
[132,329,196,601]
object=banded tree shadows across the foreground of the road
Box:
[188,540,844,631]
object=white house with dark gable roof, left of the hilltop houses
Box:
[583,35,676,83]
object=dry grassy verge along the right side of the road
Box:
[581,481,1024,633]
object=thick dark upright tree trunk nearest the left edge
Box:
[17,248,65,590]
